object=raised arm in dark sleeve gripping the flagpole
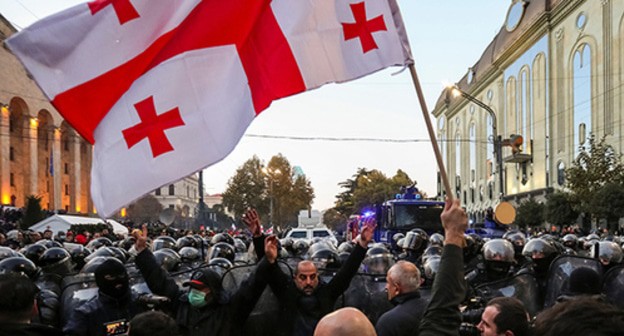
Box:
[420,200,468,336]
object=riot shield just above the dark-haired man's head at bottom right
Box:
[475,273,542,316]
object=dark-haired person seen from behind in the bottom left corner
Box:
[0,273,62,336]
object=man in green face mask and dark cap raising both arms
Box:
[134,228,277,336]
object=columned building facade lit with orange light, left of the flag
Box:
[0,15,95,214]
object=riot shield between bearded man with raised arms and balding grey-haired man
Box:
[335,274,393,325]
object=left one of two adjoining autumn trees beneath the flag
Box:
[222,155,269,218]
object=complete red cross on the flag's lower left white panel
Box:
[122,96,184,157]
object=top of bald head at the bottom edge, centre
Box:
[314,307,377,336]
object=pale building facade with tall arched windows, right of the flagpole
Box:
[433,0,624,221]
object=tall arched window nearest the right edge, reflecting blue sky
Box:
[572,44,592,157]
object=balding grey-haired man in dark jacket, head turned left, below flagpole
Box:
[375,261,427,336]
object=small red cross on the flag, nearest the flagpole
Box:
[342,2,387,53]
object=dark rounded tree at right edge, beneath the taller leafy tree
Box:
[590,183,624,231]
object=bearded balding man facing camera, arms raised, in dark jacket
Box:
[260,218,375,336]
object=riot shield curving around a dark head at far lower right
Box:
[544,255,602,309]
